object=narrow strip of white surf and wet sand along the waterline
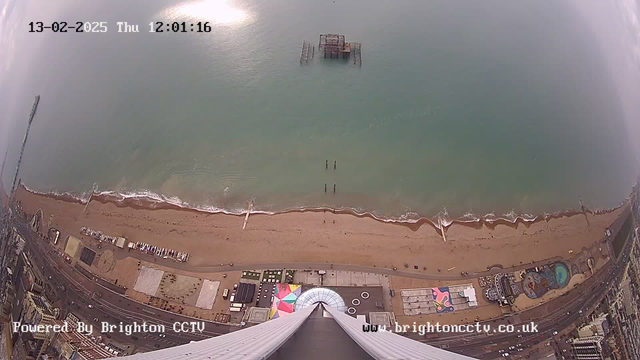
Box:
[18,182,629,234]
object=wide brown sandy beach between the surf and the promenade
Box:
[17,187,622,274]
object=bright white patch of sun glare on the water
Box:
[165,0,251,25]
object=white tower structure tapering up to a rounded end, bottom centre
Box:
[116,288,471,360]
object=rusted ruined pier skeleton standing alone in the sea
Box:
[300,34,362,66]
